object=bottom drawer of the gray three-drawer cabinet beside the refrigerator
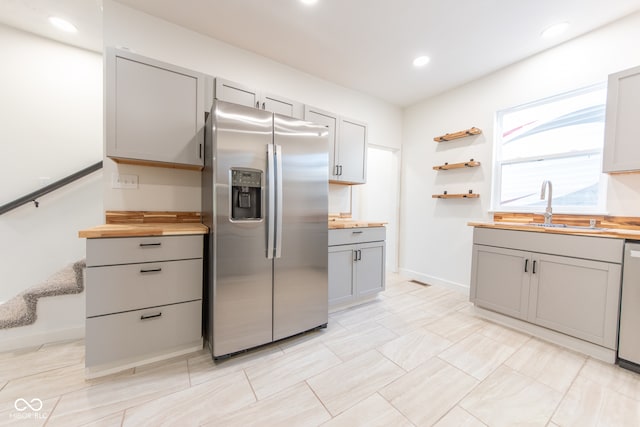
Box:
[85,301,202,367]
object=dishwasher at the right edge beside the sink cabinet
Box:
[618,242,640,372]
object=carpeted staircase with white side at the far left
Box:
[0,260,86,351]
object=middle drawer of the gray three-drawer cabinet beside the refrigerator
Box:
[86,259,202,317]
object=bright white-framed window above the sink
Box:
[493,83,607,213]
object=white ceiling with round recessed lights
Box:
[0,0,640,106]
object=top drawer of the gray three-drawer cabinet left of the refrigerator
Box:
[87,235,203,267]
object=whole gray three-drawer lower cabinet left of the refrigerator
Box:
[85,235,203,377]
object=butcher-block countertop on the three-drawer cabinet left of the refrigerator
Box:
[78,223,209,239]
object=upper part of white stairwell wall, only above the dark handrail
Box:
[0,25,102,204]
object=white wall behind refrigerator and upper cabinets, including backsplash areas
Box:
[103,0,402,214]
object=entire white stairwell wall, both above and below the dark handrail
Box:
[0,25,103,301]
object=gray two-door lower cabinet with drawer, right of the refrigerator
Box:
[329,227,385,308]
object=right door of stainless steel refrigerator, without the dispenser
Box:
[273,114,329,340]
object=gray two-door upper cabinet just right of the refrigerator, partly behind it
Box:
[304,106,367,184]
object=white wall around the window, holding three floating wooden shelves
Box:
[400,13,640,287]
